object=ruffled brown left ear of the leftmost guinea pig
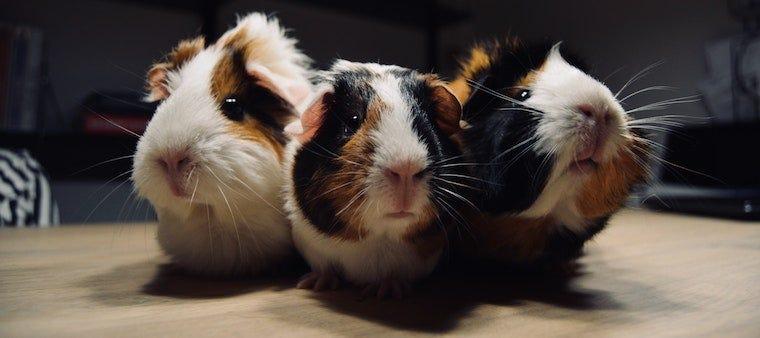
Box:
[144,37,206,102]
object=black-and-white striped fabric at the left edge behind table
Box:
[0,149,59,227]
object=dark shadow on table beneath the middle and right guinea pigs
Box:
[267,266,620,333]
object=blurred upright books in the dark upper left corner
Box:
[0,24,43,131]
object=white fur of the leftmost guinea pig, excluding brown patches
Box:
[132,13,308,274]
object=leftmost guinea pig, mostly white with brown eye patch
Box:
[132,13,312,275]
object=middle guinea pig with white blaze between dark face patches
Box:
[286,60,467,298]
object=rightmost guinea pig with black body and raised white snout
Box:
[451,39,649,266]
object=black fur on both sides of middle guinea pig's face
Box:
[293,62,470,239]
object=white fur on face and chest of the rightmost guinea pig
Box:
[520,45,629,230]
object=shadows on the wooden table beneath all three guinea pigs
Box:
[82,260,636,333]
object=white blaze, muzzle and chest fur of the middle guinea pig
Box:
[285,61,440,285]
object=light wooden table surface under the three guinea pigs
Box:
[0,211,760,337]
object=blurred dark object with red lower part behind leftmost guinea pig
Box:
[80,92,157,136]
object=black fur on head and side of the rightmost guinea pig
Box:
[463,43,585,214]
